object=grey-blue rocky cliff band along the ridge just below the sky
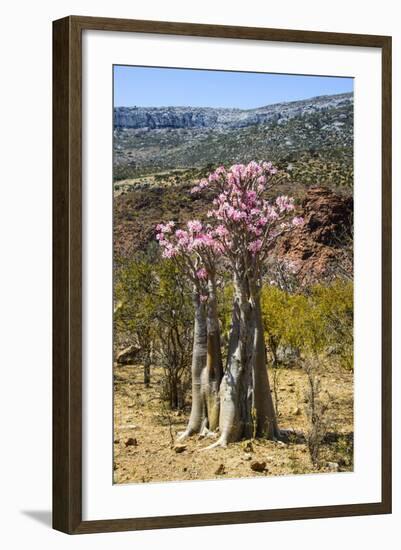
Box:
[114,94,353,130]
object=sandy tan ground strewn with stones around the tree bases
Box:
[114,366,353,483]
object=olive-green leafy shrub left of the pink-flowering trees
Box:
[114,257,193,408]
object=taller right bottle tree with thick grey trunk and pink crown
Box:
[155,161,303,446]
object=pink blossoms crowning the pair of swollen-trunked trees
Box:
[156,161,303,264]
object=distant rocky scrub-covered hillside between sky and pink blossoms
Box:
[114,90,353,187]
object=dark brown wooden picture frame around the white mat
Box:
[53,16,391,534]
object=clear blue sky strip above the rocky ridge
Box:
[114,65,353,109]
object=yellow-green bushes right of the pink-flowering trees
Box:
[261,280,353,369]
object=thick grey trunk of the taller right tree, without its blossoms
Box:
[215,276,279,446]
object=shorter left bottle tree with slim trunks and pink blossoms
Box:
[156,220,223,440]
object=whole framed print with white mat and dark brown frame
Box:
[53,16,391,534]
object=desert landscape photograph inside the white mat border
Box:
[113,65,354,484]
